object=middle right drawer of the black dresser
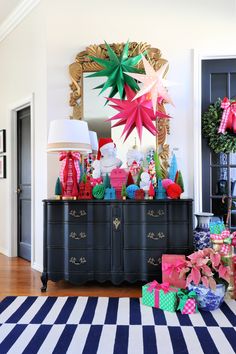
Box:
[124,223,168,249]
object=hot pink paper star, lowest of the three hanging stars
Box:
[108,85,170,141]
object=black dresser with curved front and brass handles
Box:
[41,199,193,291]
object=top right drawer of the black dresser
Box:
[124,203,167,223]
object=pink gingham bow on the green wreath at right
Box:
[218,97,236,134]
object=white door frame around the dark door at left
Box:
[7,94,35,266]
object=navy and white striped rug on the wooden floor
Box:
[0,296,236,354]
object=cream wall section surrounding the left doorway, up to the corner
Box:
[0,4,47,268]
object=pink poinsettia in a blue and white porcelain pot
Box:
[179,248,230,311]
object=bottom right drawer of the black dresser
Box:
[124,249,165,274]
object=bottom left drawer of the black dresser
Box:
[66,250,111,273]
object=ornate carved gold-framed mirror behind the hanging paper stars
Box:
[69,42,169,177]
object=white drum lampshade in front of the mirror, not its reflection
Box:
[47,119,92,153]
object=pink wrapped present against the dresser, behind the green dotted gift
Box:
[162,254,186,289]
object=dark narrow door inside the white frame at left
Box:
[16,106,32,261]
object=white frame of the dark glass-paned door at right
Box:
[193,49,236,213]
